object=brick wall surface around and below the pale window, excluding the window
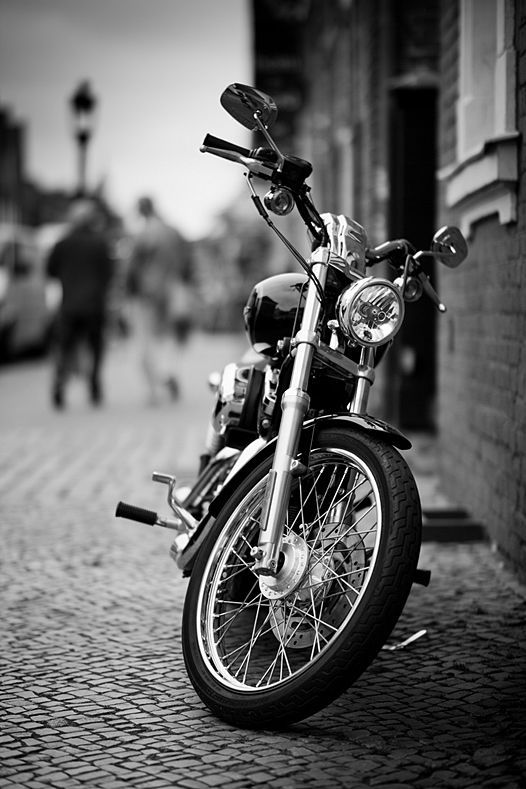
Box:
[438,0,526,579]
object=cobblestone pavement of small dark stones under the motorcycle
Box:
[0,337,526,789]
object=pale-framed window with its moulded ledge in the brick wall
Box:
[446,0,518,235]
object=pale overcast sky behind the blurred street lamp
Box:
[0,0,252,238]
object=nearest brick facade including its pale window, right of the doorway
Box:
[437,0,526,579]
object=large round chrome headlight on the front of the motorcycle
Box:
[337,277,404,347]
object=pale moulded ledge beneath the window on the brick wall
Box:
[438,133,519,236]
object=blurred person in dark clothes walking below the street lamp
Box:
[47,198,113,408]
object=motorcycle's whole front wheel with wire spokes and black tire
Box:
[182,426,421,728]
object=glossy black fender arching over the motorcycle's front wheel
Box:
[177,413,411,575]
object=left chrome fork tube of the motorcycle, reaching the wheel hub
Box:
[252,247,329,575]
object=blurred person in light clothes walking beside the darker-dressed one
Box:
[128,197,191,404]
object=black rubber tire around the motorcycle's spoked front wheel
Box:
[183,428,422,729]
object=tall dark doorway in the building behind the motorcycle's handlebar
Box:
[388,86,437,431]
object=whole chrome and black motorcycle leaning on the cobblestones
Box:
[116,83,467,728]
